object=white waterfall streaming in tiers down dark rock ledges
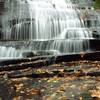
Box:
[0,0,92,57]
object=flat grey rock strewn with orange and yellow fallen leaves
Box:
[0,60,100,100]
